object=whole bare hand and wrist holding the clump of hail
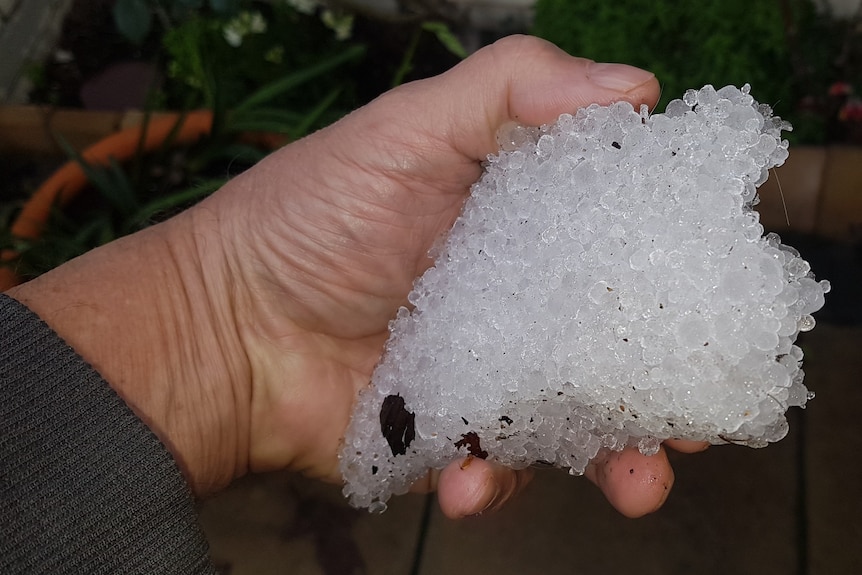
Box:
[12,37,704,516]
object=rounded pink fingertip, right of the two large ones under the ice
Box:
[585,448,674,517]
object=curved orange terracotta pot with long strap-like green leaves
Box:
[0,36,363,289]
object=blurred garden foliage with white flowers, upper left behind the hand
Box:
[5,0,466,279]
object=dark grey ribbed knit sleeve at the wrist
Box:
[0,294,215,574]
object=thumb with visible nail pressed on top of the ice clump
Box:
[432,36,660,160]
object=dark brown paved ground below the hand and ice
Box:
[197,325,862,575]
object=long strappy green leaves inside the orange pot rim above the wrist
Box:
[0,46,363,280]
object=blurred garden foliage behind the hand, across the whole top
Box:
[0,0,862,277]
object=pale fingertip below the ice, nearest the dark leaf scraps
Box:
[437,457,533,519]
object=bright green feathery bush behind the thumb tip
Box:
[533,0,791,112]
